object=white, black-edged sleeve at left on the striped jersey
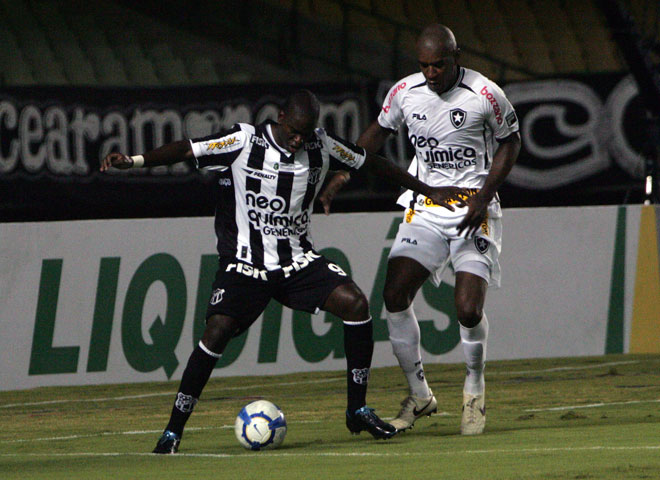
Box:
[190,124,248,171]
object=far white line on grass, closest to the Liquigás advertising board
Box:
[0,360,639,408]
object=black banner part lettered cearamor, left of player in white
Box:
[0,86,365,221]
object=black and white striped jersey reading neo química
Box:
[190,122,366,270]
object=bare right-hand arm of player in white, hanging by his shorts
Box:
[456,132,520,238]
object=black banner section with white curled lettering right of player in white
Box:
[501,75,649,206]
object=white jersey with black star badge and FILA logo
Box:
[378,67,518,218]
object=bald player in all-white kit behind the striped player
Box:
[320,25,520,435]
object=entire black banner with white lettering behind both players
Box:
[0,75,645,221]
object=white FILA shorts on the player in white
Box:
[389,210,502,288]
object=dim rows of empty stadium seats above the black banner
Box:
[0,0,657,86]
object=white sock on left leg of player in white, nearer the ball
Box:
[385,304,431,398]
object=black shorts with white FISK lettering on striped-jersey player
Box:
[206,252,353,335]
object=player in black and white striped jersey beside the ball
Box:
[101,90,461,454]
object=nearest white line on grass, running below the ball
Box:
[0,445,660,461]
